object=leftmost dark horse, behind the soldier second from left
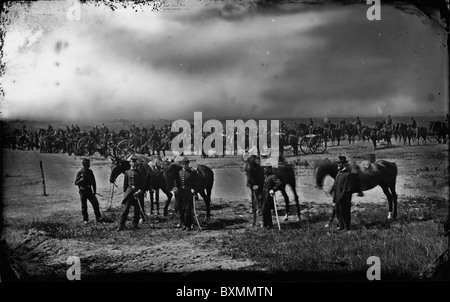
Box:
[109,154,173,216]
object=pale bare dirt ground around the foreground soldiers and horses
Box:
[2,141,449,280]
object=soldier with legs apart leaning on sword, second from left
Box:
[117,155,145,231]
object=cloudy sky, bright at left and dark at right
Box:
[0,1,449,121]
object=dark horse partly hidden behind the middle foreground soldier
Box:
[164,162,214,220]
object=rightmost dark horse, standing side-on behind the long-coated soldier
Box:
[314,159,397,219]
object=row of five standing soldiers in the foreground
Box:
[75,155,362,232]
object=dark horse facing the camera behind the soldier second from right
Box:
[243,155,300,225]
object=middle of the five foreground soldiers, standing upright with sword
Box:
[174,157,198,231]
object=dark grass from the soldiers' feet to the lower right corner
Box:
[10,197,448,280]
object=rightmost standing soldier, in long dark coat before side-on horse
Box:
[330,156,354,231]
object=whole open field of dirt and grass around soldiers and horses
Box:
[2,134,449,281]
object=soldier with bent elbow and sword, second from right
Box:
[261,162,282,229]
